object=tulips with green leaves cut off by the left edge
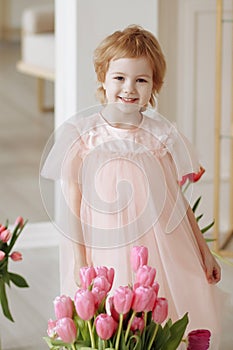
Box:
[0,216,28,322]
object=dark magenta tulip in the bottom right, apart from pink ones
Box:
[187,329,211,350]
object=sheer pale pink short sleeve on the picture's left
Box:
[41,123,82,182]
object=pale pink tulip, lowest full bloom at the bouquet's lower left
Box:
[56,317,77,344]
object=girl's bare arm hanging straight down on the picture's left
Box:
[66,181,87,284]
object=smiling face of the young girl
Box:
[103,57,153,112]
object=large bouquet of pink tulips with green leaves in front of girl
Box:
[44,246,210,350]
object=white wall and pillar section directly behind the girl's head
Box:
[55,0,158,125]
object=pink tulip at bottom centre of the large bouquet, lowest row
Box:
[95,314,116,340]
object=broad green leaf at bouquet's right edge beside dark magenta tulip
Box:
[161,313,189,350]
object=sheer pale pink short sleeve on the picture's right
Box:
[167,127,201,181]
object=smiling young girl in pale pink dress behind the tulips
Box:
[42,26,221,349]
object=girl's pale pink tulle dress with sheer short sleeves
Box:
[42,113,224,349]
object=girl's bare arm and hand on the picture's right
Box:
[187,206,221,284]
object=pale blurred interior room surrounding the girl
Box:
[0,0,233,350]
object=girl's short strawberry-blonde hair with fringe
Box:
[94,25,166,107]
